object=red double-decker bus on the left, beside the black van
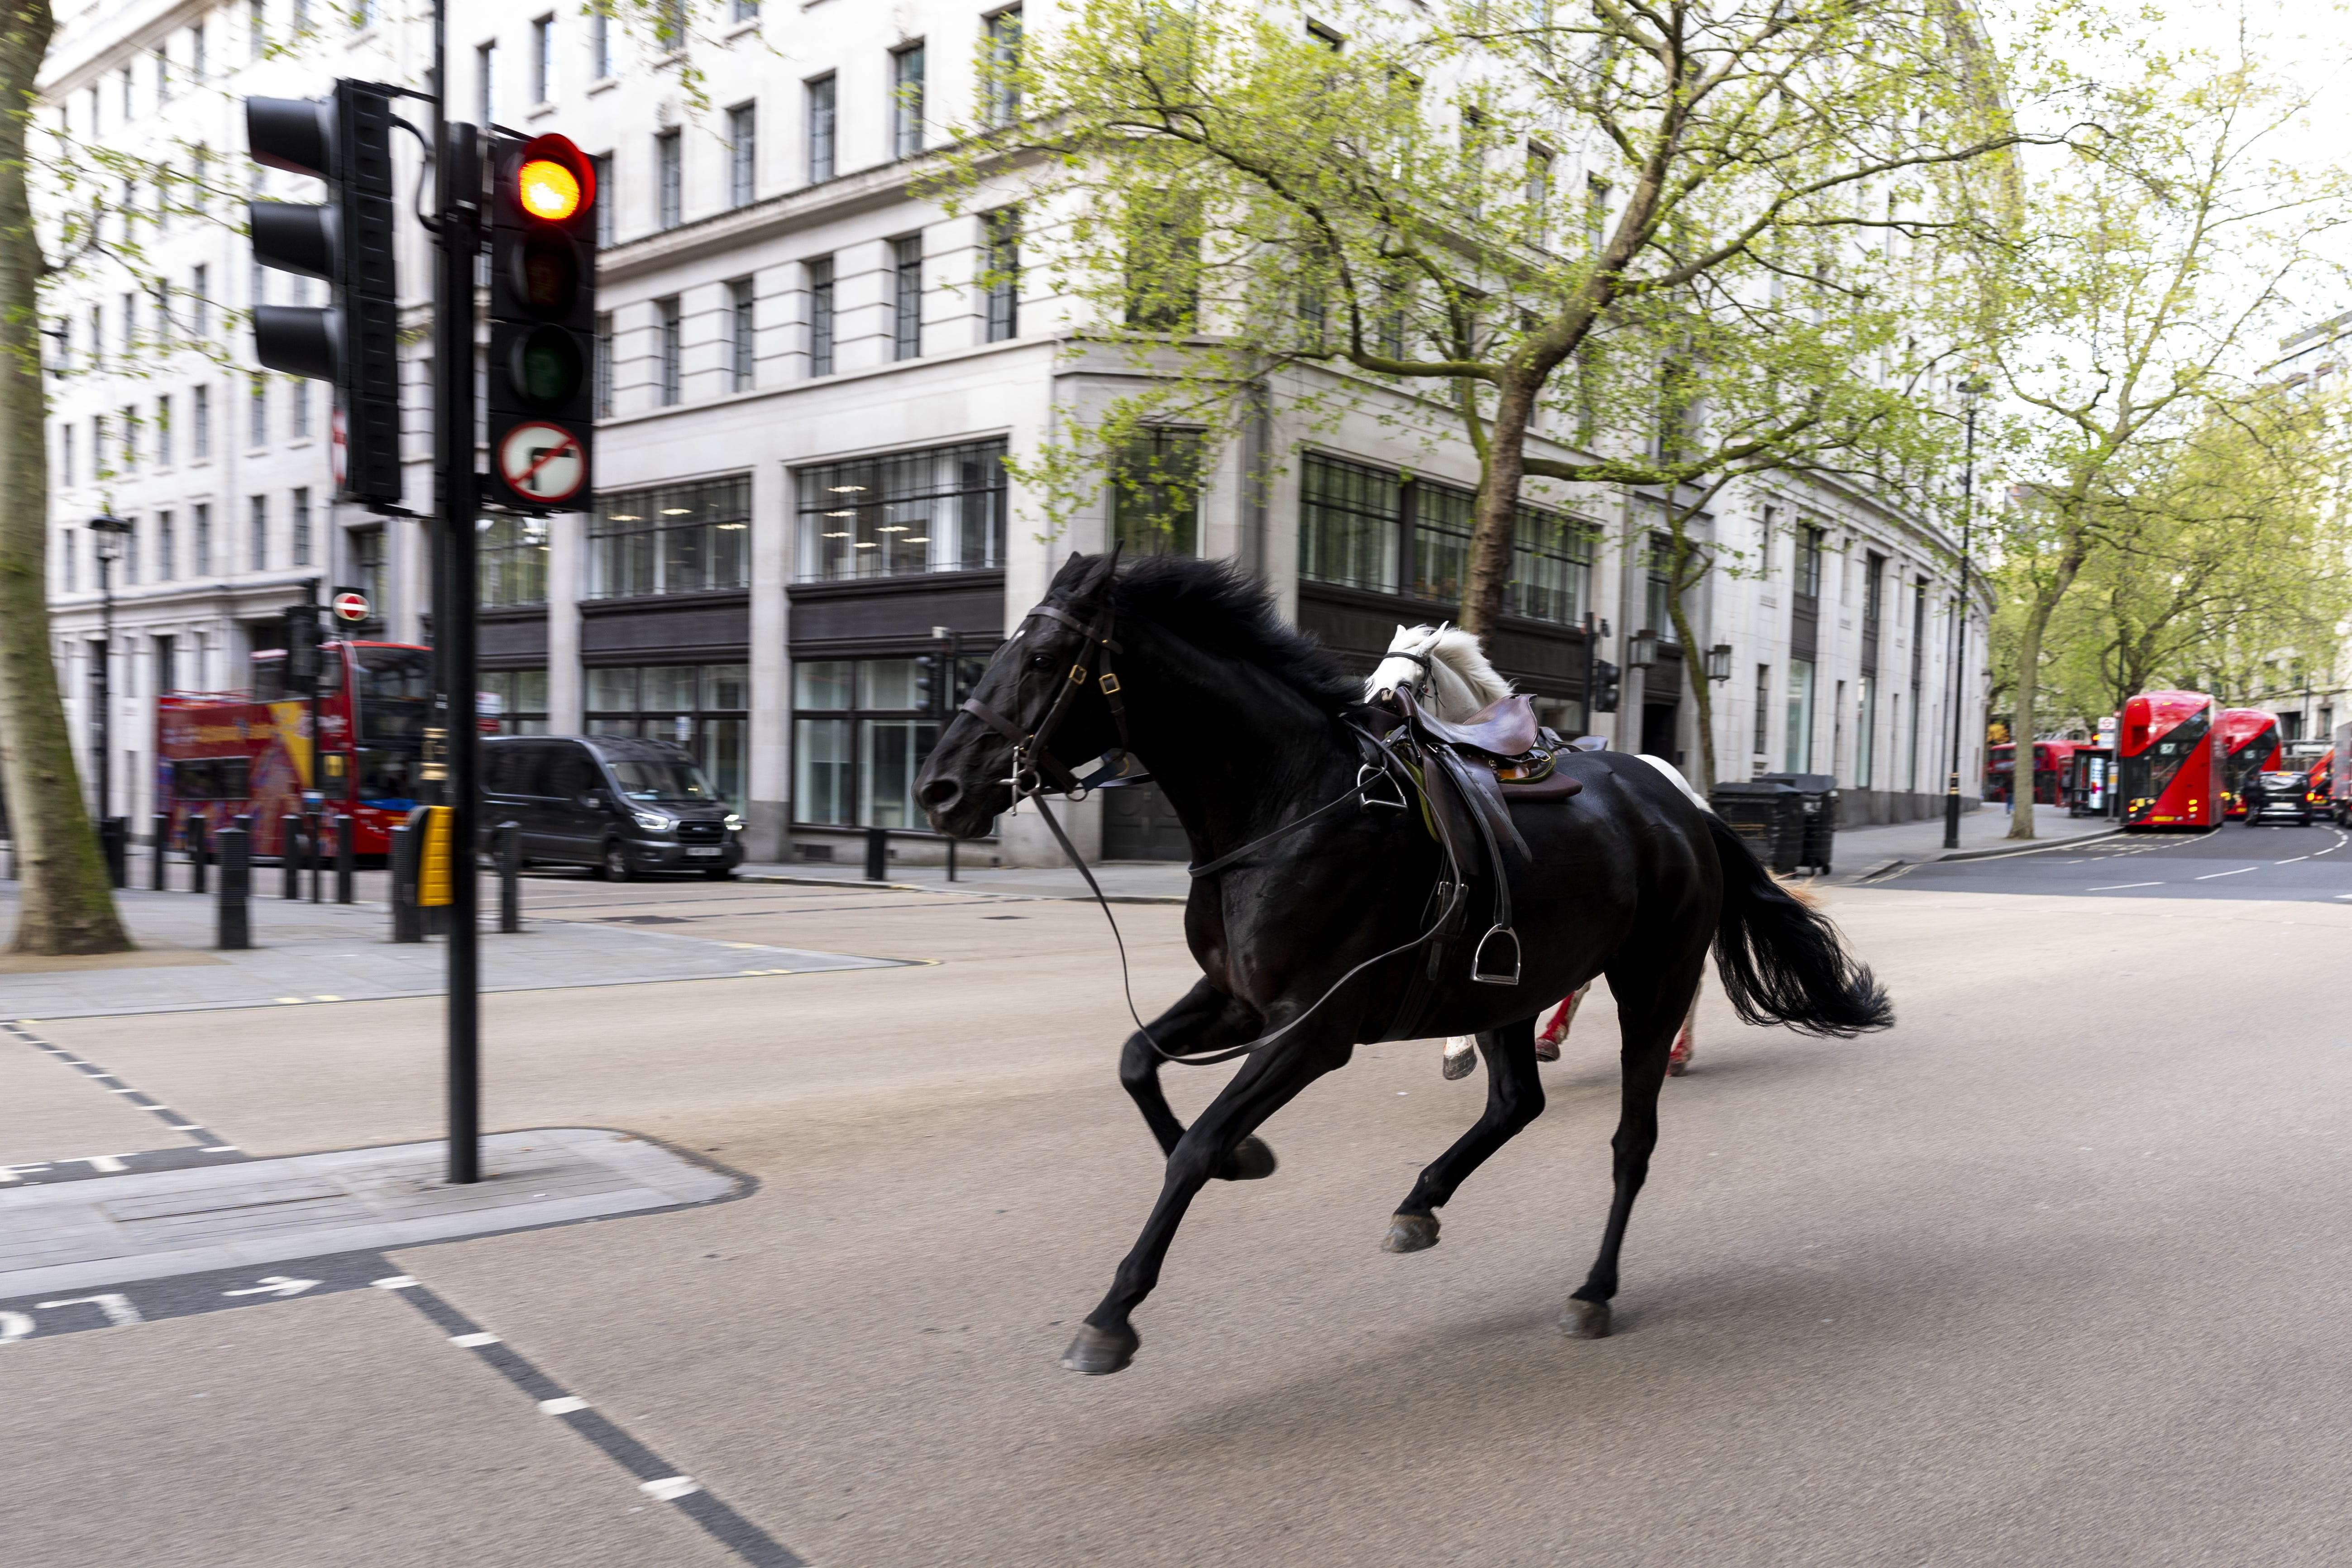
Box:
[155,642,433,856]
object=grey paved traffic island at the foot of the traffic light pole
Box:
[0,1128,743,1300]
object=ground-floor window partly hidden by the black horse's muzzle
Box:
[793,656,988,827]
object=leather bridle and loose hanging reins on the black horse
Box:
[957,590,1468,1067]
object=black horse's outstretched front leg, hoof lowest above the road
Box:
[1061,1025,1353,1373]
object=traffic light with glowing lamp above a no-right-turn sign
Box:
[489,134,598,512]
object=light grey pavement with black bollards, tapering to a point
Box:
[0,884,908,1018]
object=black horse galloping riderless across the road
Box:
[915,555,1893,1373]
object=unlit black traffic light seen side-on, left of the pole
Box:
[244,82,400,506]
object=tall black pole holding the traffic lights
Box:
[433,0,482,1182]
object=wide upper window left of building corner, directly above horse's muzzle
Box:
[800,442,1004,581]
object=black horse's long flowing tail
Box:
[1707,811,1896,1039]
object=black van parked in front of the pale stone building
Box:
[480,736,743,882]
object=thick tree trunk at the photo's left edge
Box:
[0,0,132,952]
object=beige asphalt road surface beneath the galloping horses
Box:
[0,865,2352,1568]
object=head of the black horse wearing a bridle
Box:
[915,555,1117,839]
